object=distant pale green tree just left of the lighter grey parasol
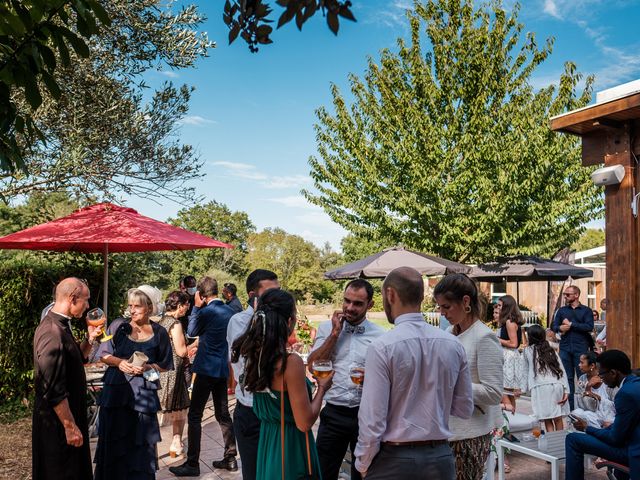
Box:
[246,228,324,300]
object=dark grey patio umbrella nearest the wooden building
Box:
[469,255,593,322]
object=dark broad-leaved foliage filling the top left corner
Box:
[0,0,110,171]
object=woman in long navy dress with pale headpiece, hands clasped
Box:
[94,285,173,480]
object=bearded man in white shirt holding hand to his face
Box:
[308,279,384,480]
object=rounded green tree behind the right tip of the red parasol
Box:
[169,201,255,278]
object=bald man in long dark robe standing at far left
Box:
[31,278,100,480]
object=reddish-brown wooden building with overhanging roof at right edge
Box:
[551,81,640,367]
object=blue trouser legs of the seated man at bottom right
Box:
[564,432,629,480]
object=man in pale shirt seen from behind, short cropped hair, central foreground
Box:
[355,267,473,480]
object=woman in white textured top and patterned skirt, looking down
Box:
[433,274,503,480]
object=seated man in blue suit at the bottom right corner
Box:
[565,350,640,480]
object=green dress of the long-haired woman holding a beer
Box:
[253,379,322,480]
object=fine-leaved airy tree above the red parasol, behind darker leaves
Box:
[0,0,213,201]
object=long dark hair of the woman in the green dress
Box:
[231,288,296,392]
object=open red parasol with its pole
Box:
[0,203,233,313]
